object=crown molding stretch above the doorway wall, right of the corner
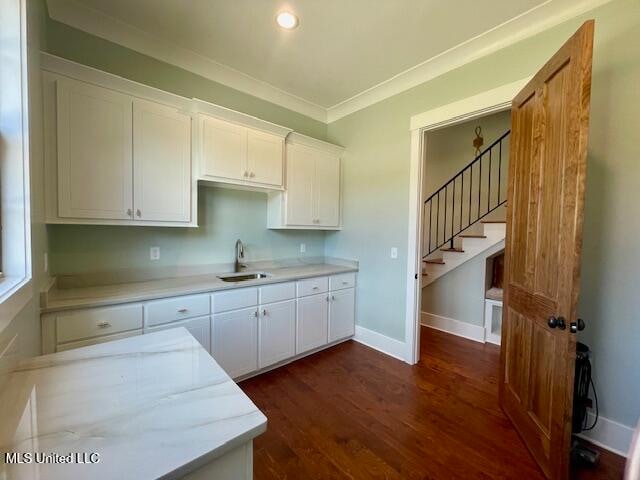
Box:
[327,0,611,123]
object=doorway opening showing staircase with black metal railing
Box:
[418,109,511,344]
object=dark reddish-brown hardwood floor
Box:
[240,328,624,480]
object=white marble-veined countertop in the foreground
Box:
[0,328,267,480]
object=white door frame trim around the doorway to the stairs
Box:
[405,77,532,365]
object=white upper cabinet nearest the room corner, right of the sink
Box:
[267,133,344,230]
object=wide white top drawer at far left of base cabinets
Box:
[56,304,142,343]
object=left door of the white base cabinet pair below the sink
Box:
[211,308,258,378]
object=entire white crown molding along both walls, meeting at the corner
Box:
[46,0,612,123]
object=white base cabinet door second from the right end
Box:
[296,294,329,354]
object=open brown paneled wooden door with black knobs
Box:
[500,21,593,479]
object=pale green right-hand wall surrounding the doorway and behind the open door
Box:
[325,0,640,425]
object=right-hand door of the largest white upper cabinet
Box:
[133,100,191,222]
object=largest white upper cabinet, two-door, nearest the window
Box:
[43,61,197,227]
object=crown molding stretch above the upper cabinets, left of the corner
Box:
[47,0,327,123]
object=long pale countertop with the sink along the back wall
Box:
[41,263,358,313]
